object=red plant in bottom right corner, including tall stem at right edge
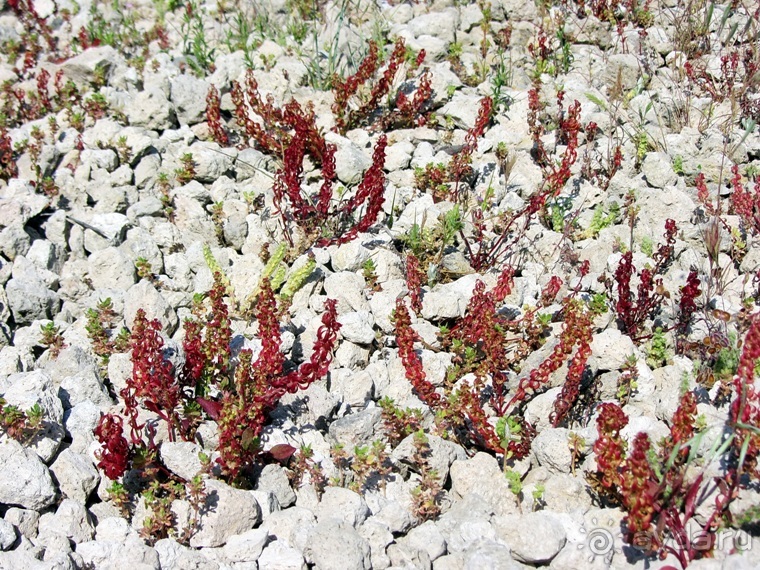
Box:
[587,315,760,568]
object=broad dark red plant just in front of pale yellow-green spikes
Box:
[95,273,340,485]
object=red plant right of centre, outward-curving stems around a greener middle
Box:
[393,267,591,459]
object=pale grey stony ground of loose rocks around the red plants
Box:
[0,0,760,570]
